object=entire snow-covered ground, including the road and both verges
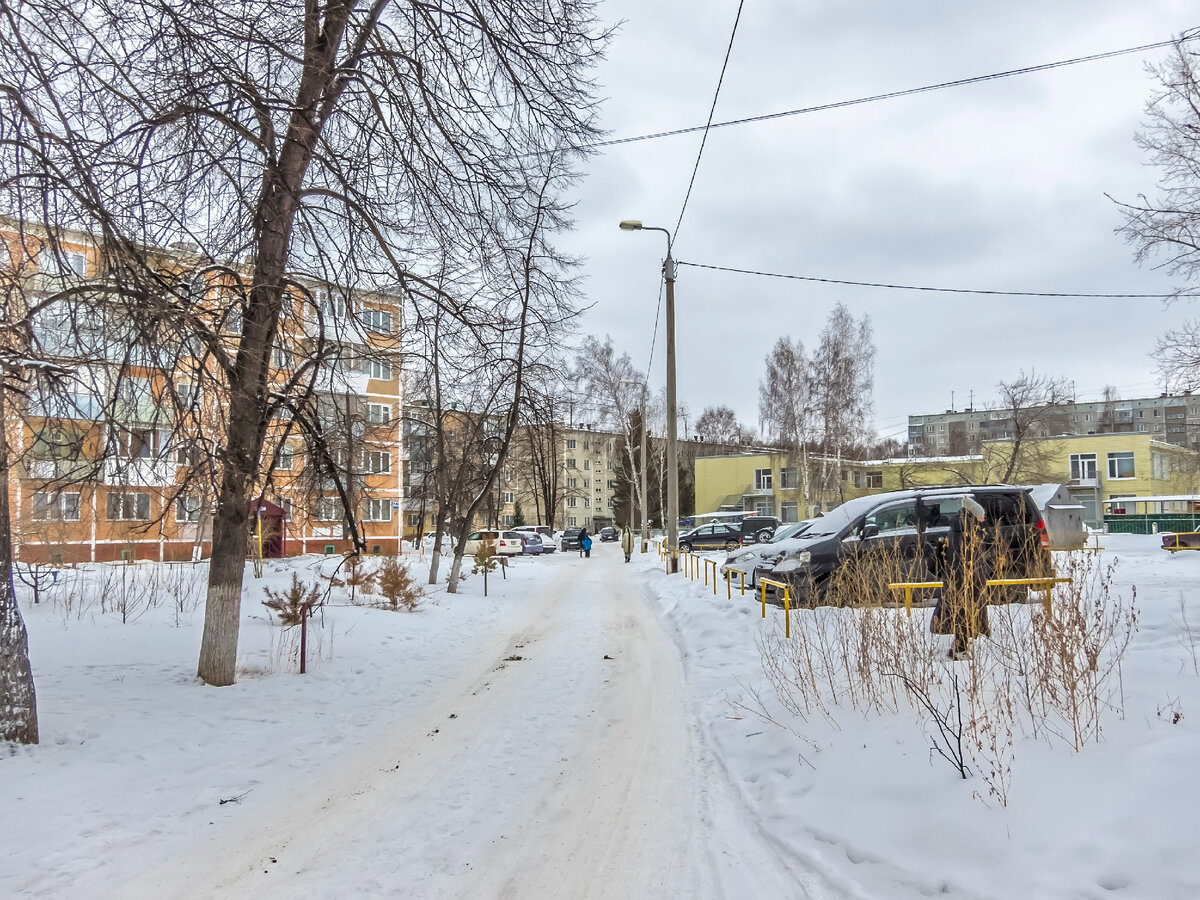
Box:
[0,535,1200,898]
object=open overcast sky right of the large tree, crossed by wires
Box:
[566,0,1200,439]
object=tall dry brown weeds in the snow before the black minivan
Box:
[740,535,1138,805]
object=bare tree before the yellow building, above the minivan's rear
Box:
[988,371,1072,484]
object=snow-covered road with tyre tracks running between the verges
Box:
[112,552,823,898]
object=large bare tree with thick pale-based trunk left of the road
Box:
[0,0,606,685]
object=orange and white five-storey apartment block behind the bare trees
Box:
[0,222,403,563]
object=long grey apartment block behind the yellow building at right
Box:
[908,391,1200,456]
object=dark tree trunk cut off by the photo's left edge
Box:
[0,373,37,744]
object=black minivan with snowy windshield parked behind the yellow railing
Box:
[755,485,1052,605]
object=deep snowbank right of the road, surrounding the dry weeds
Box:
[642,535,1200,898]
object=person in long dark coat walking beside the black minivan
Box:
[930,497,991,659]
